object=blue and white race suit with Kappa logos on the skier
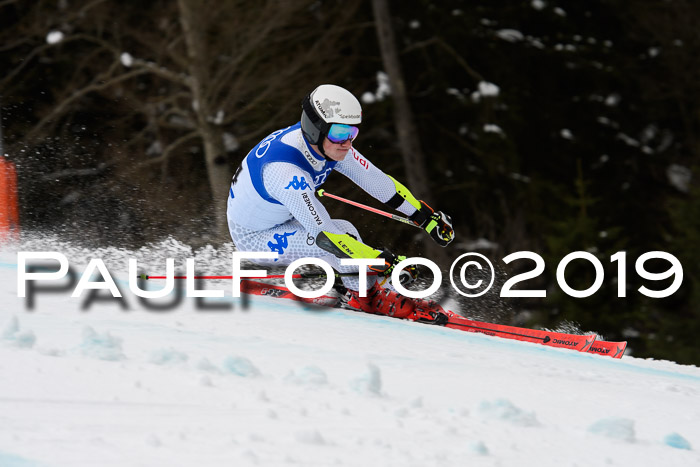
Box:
[227,123,416,290]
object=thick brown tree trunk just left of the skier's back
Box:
[178,0,231,236]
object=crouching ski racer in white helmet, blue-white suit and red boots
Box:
[227,84,454,324]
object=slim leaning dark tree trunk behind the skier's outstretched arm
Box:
[372,0,448,267]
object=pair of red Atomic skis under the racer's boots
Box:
[241,279,627,358]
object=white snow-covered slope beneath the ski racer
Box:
[0,248,700,467]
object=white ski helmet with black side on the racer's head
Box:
[301,84,362,146]
